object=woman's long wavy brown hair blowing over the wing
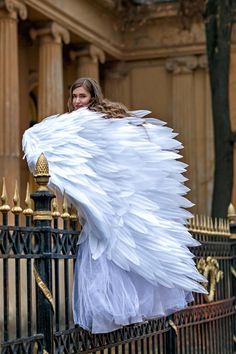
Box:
[67,77,131,118]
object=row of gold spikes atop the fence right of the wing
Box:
[188,215,231,237]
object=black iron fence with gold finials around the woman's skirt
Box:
[0,156,236,354]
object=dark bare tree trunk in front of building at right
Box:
[178,0,236,217]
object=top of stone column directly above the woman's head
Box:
[70,44,105,82]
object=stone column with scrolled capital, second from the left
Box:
[30,22,70,120]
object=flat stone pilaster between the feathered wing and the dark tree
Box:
[166,56,213,214]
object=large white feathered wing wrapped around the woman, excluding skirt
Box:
[23,108,206,292]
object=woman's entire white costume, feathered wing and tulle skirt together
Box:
[23,108,206,333]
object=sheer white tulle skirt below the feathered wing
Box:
[73,239,193,333]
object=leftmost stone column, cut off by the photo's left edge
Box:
[0,0,27,197]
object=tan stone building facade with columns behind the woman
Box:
[0,0,236,214]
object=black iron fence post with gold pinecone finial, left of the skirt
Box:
[31,154,55,354]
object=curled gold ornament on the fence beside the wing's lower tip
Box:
[197,256,223,302]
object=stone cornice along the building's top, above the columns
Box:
[24,0,210,61]
